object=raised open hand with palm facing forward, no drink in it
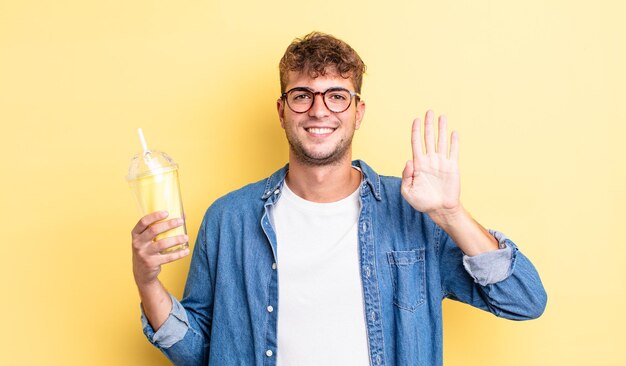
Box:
[401,110,462,217]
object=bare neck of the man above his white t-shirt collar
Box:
[285,155,361,203]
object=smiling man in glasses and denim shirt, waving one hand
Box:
[132,33,546,366]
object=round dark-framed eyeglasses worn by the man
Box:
[280,87,361,113]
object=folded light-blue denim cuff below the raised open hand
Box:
[463,229,515,286]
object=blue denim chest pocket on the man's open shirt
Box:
[387,248,426,311]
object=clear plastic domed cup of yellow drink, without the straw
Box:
[126,151,189,253]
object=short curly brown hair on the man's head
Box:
[279,32,365,93]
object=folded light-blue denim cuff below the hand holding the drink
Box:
[140,294,189,348]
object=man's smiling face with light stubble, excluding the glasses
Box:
[277,70,365,166]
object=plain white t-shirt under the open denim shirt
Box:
[271,184,370,366]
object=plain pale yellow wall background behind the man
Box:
[0,0,626,365]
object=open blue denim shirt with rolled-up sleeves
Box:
[142,160,547,366]
